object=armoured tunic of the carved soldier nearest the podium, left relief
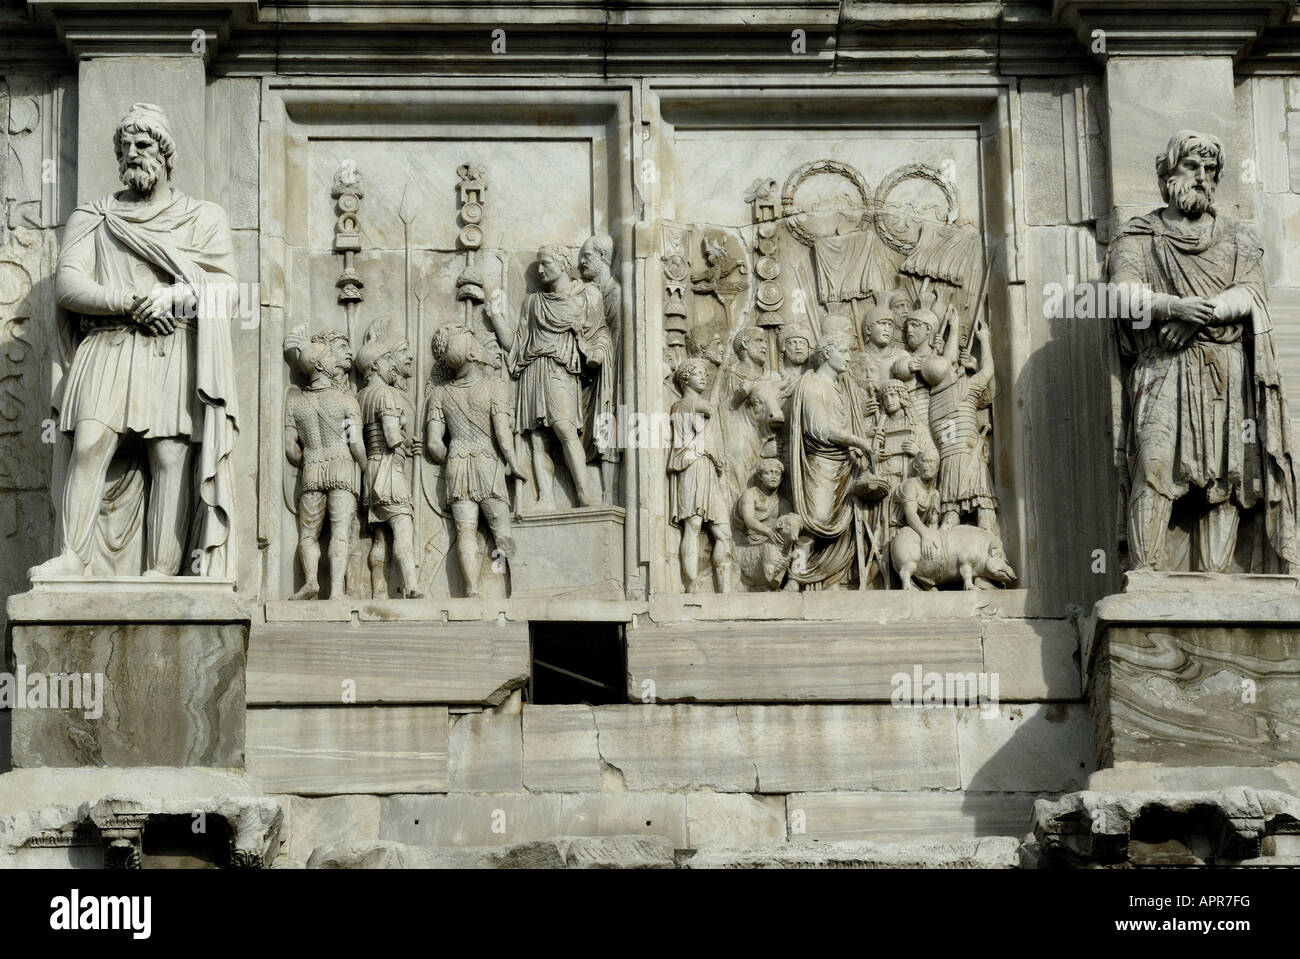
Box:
[425,377,514,503]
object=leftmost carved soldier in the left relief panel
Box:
[285,330,365,599]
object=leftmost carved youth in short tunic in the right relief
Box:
[668,357,732,593]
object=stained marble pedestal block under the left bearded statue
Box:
[0,577,250,768]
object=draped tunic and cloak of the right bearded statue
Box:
[1108,211,1300,540]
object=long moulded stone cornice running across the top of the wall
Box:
[0,0,1296,77]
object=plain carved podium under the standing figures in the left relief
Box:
[510,507,625,599]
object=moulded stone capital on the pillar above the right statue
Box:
[1053,0,1296,61]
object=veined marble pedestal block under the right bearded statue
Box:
[1083,573,1300,789]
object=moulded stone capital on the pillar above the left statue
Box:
[29,0,257,65]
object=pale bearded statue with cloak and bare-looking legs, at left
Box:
[30,103,238,576]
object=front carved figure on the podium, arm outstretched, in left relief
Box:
[484,247,611,507]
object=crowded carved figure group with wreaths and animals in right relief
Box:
[662,159,1015,593]
